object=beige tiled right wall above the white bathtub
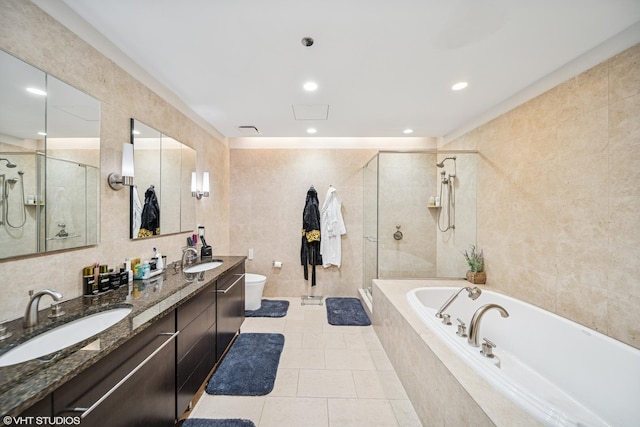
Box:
[445,45,640,348]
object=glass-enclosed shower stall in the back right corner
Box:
[363,151,477,296]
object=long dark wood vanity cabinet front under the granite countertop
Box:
[16,263,245,427]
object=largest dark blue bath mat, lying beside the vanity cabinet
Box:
[206,333,284,396]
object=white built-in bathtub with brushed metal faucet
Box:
[407,287,640,427]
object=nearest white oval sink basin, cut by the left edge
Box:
[0,307,131,367]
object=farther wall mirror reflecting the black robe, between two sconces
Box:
[130,119,196,239]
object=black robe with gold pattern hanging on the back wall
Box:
[300,187,322,286]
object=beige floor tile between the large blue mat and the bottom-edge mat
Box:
[189,393,266,425]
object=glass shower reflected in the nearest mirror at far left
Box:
[0,152,100,258]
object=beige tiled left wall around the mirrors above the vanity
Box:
[0,0,229,320]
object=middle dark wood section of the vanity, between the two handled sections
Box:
[176,282,216,418]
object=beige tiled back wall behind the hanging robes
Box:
[230,149,376,297]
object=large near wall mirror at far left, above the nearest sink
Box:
[0,51,100,258]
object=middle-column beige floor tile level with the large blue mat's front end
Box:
[298,369,357,397]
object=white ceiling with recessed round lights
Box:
[42,0,640,137]
